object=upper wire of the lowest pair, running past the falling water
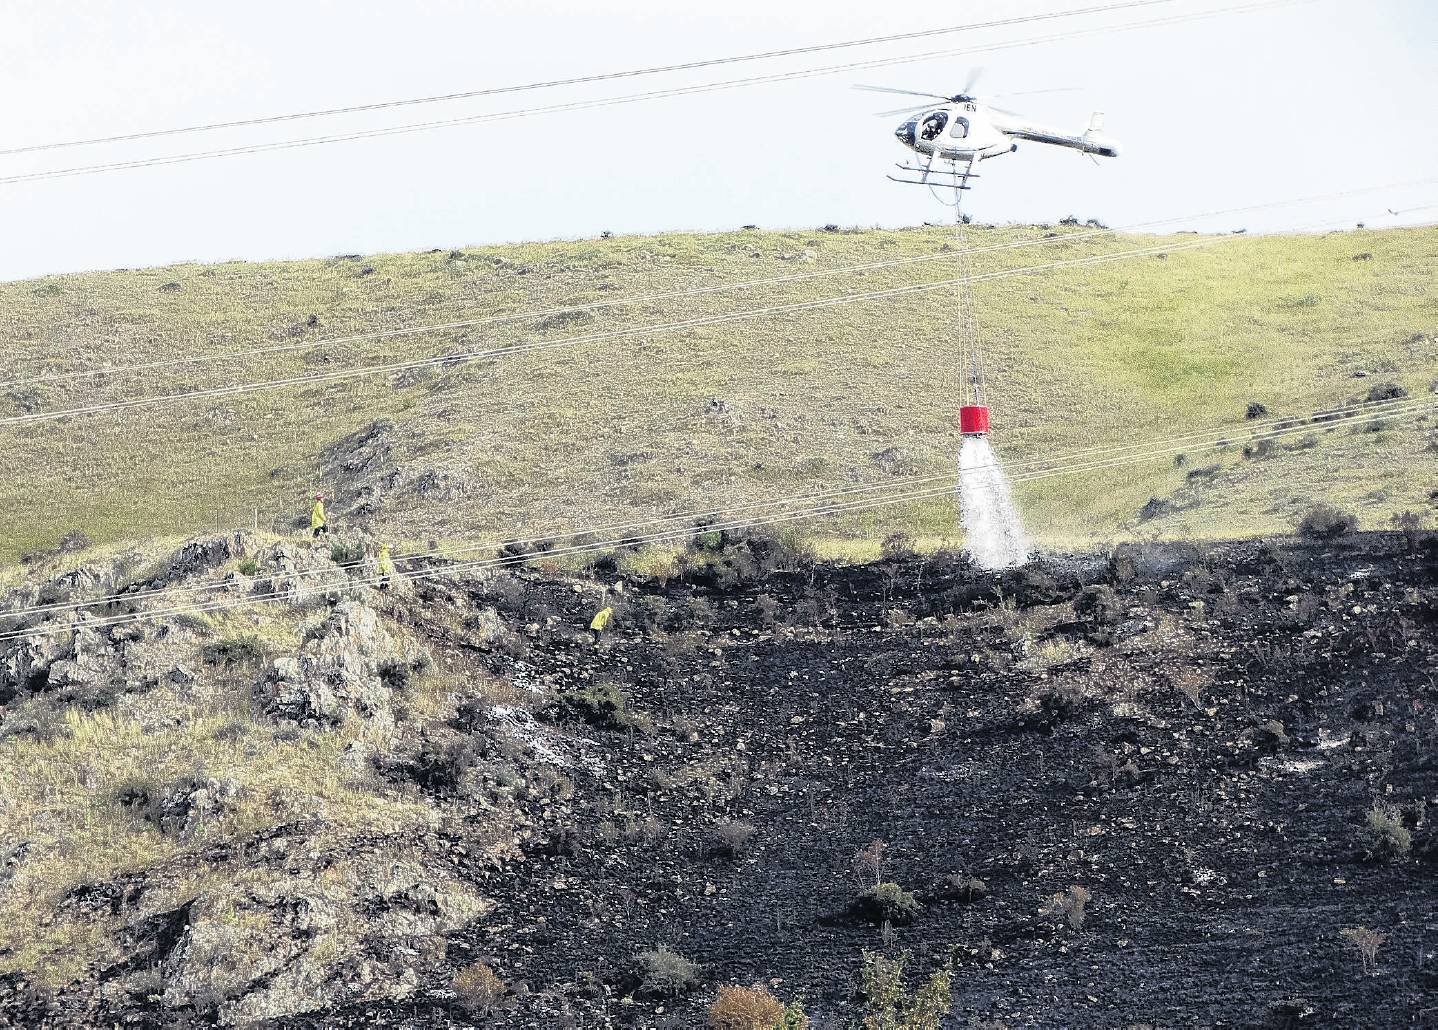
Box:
[0,398,1438,624]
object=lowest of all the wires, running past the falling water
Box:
[0,401,1438,640]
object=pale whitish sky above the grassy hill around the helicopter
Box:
[0,0,1438,281]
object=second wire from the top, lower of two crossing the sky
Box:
[0,0,1314,186]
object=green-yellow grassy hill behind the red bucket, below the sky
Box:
[0,227,1438,562]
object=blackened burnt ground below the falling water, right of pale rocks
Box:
[11,534,1438,1027]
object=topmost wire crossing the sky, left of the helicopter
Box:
[0,0,1178,157]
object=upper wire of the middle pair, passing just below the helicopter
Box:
[8,177,1438,388]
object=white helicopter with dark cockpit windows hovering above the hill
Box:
[856,73,1119,190]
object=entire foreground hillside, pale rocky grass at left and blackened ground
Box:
[0,531,1438,1030]
